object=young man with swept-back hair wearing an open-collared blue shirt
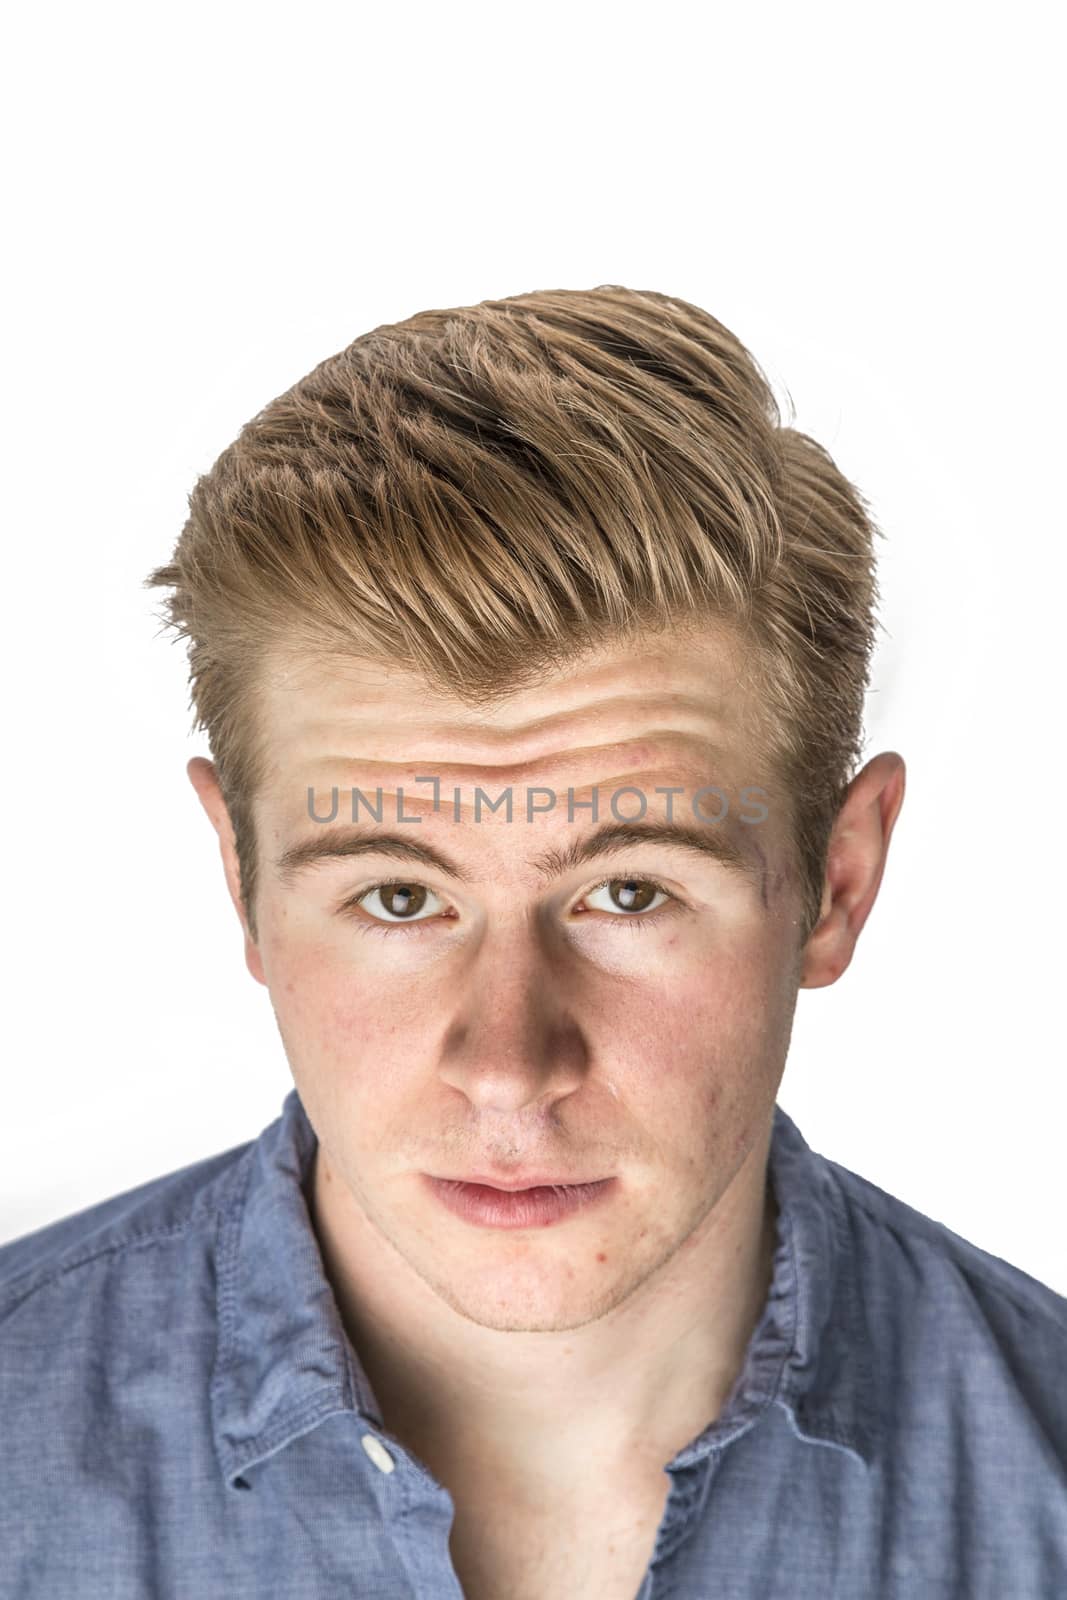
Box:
[0,286,1067,1600]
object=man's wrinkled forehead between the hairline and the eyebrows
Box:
[249,629,779,842]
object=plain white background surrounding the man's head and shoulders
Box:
[0,3,1067,1293]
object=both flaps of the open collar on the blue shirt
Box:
[211,1090,875,1486]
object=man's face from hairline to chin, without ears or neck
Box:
[227,630,800,1330]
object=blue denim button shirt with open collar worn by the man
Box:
[0,1090,1067,1600]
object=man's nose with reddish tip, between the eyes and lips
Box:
[438,928,590,1112]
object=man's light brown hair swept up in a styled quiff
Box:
[146,283,880,939]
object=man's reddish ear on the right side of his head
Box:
[800,750,905,989]
